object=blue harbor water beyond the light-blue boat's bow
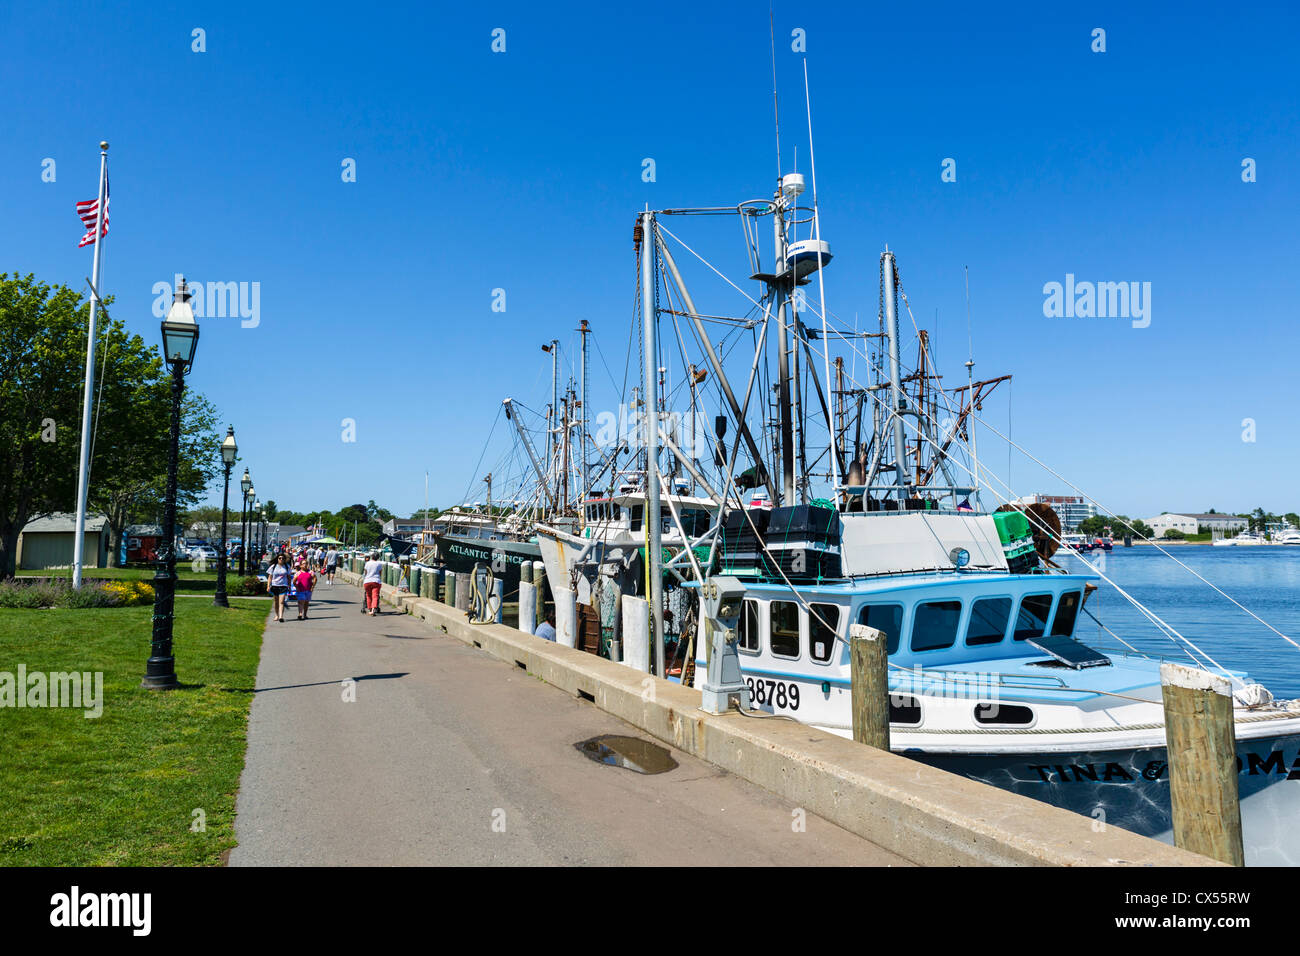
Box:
[1058,545,1300,698]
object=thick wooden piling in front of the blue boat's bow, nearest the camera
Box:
[1160,663,1245,866]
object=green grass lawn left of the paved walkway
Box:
[0,598,268,866]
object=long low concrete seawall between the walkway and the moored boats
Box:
[341,571,1218,866]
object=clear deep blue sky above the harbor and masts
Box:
[0,3,1300,516]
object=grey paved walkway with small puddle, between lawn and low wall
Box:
[230,583,905,866]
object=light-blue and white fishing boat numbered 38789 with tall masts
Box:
[590,145,1300,864]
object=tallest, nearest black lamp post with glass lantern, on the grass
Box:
[140,278,199,691]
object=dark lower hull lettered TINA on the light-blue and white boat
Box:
[902,734,1300,866]
